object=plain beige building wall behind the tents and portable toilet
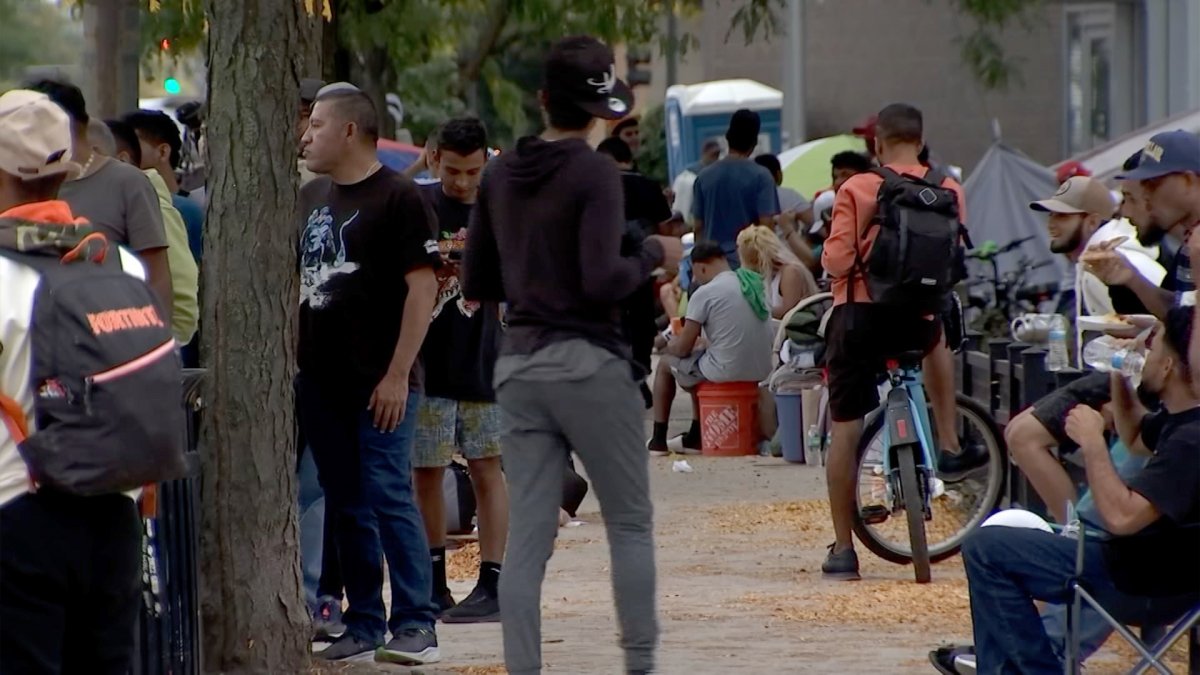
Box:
[642,0,1063,169]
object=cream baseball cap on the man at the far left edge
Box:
[0,89,83,180]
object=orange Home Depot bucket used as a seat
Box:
[696,382,758,456]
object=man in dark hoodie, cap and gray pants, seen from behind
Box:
[463,37,682,675]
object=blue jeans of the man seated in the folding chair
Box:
[962,526,1112,675]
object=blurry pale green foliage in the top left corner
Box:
[0,0,83,90]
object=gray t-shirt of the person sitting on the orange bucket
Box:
[688,271,772,382]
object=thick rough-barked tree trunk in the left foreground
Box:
[200,0,319,673]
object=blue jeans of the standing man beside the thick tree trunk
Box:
[299,376,436,643]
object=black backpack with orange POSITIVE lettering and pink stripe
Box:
[0,239,187,496]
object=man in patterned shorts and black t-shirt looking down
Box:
[413,118,509,623]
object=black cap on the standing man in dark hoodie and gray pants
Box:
[544,35,634,120]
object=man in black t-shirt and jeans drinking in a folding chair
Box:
[962,307,1200,674]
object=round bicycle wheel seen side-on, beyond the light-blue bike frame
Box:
[854,395,1008,565]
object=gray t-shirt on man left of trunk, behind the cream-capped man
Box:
[59,157,167,251]
